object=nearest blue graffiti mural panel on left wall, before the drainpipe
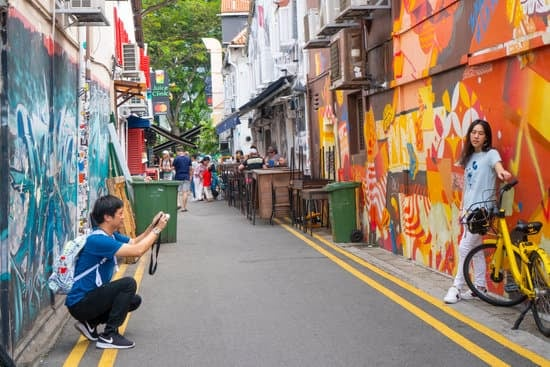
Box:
[0,10,78,345]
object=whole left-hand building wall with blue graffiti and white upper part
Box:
[0,0,148,363]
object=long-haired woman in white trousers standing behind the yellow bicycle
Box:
[443,119,512,303]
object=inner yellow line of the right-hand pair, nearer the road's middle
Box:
[278,221,509,366]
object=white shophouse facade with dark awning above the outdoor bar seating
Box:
[218,1,309,174]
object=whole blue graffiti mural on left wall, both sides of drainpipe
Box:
[0,12,114,349]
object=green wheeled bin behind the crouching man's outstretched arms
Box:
[132,179,180,243]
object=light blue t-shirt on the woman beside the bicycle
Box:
[462,149,502,210]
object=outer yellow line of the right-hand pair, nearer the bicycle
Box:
[314,230,550,366]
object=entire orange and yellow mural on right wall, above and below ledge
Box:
[362,1,550,274]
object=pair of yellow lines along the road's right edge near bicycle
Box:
[276,220,550,366]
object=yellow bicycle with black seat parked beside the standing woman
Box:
[463,180,550,336]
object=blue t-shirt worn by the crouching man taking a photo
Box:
[65,232,130,307]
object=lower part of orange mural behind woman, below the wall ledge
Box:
[363,49,550,274]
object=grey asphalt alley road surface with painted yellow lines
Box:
[39,201,550,367]
